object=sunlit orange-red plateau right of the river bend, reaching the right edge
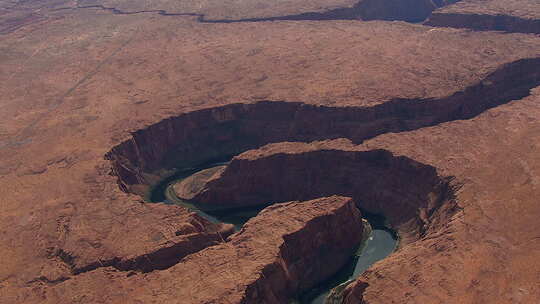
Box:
[336,87,540,304]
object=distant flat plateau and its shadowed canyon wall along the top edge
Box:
[68,0,460,23]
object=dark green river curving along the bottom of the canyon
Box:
[148,162,398,304]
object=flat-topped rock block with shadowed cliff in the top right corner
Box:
[424,0,540,34]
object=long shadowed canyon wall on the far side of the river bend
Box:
[106,58,540,193]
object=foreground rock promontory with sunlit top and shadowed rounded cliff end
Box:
[46,196,363,304]
